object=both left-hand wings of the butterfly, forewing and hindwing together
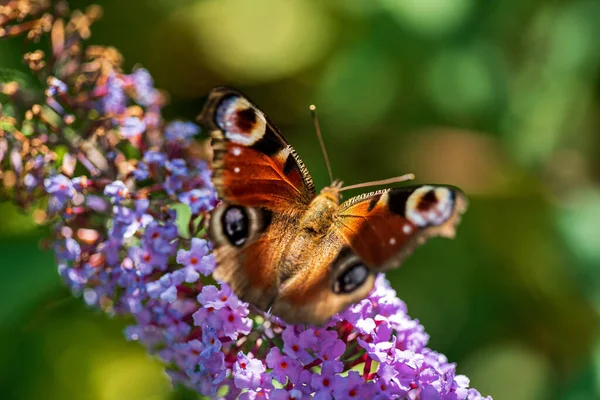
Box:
[200,88,315,309]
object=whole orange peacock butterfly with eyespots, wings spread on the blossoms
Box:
[199,87,467,325]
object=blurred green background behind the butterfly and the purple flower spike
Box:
[0,0,600,400]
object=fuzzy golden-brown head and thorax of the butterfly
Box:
[300,183,340,235]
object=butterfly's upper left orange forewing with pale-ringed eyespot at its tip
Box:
[200,87,315,212]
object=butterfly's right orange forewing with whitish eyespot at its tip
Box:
[334,185,467,271]
